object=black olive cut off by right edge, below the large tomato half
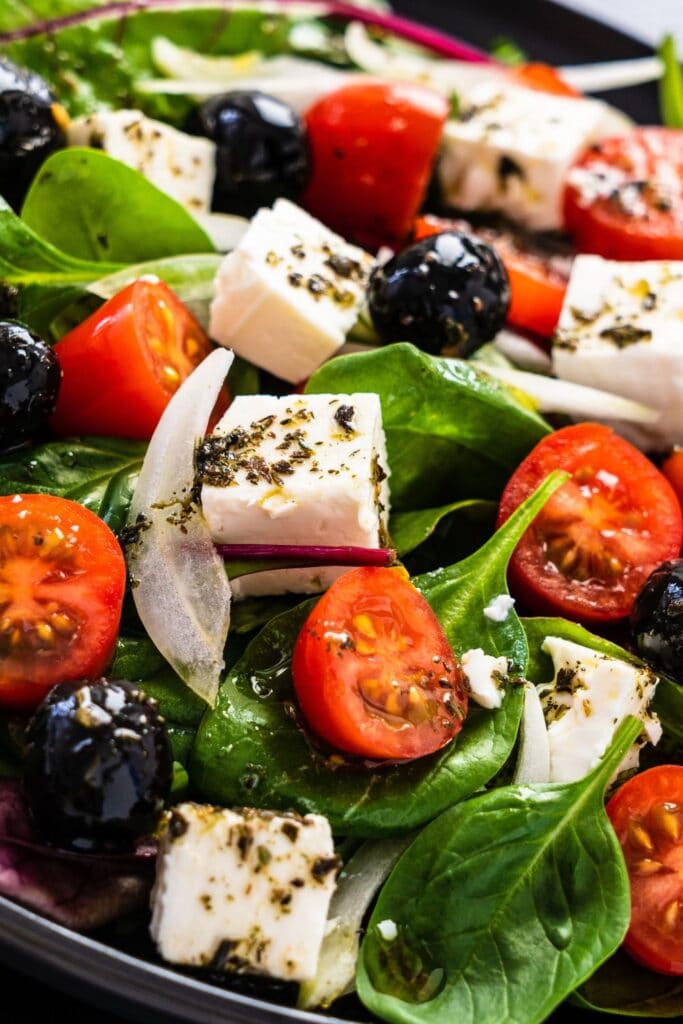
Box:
[631,558,683,682]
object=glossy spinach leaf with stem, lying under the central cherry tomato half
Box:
[190,477,561,837]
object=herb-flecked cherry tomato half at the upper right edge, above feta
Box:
[563,127,683,260]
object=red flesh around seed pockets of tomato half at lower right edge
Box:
[606,765,683,975]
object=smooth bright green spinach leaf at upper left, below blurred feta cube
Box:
[22,146,213,268]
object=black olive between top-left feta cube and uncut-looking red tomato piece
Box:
[185,91,310,217]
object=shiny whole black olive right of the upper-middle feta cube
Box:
[368,231,510,356]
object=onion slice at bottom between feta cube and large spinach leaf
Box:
[298,837,413,1010]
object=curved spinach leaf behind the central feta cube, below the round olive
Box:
[306,343,550,512]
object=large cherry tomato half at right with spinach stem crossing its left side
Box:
[498,423,683,623]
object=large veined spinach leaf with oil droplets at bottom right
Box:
[356,719,641,1024]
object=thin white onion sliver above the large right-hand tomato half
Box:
[482,366,659,424]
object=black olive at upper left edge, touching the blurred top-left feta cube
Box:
[0,89,66,210]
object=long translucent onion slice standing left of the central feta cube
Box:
[128,348,233,707]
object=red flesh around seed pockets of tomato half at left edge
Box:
[0,494,126,710]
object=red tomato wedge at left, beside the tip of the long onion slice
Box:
[52,279,211,440]
